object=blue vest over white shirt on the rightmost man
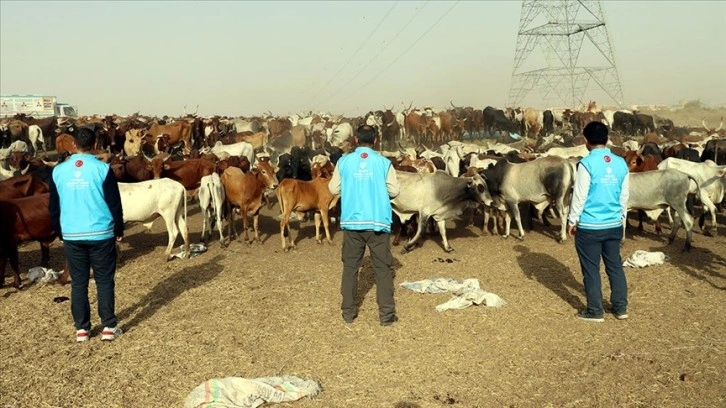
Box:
[577,148,628,230]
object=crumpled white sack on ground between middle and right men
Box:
[400,278,507,312]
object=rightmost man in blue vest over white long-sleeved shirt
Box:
[567,122,630,322]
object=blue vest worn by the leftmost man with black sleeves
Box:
[53,153,114,241]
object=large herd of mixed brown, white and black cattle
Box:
[0,102,726,287]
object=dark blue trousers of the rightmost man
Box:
[575,227,628,316]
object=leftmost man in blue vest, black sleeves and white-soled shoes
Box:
[49,128,124,342]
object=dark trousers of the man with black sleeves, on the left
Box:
[63,238,117,330]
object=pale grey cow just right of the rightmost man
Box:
[623,169,698,251]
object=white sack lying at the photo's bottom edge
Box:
[184,375,320,408]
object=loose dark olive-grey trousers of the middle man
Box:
[340,230,396,322]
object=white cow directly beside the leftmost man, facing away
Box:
[118,178,189,261]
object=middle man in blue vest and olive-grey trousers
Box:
[328,125,399,326]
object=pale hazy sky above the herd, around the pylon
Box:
[0,1,726,115]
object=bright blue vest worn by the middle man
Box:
[338,147,393,232]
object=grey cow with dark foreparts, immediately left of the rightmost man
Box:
[484,156,575,243]
